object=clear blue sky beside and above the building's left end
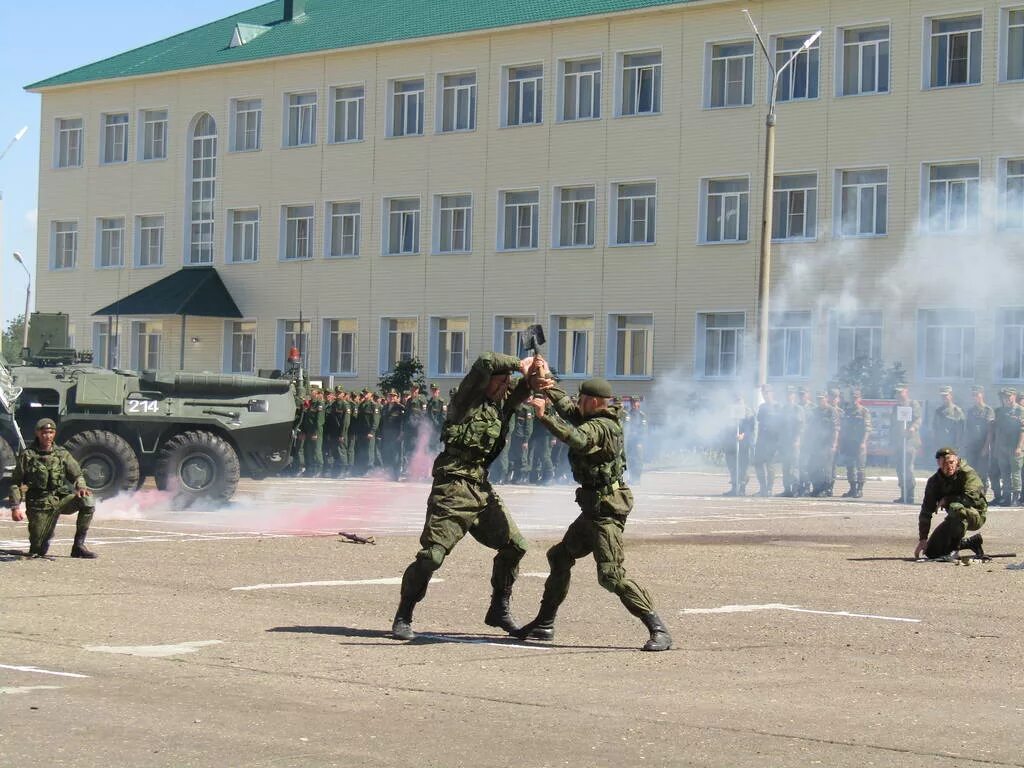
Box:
[0,0,256,328]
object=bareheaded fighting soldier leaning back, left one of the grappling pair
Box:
[391,352,534,640]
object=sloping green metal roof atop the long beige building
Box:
[26,0,694,90]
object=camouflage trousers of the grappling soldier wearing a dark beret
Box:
[538,487,654,620]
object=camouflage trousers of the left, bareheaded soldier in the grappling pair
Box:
[401,473,526,603]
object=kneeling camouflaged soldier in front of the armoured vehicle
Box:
[10,419,96,559]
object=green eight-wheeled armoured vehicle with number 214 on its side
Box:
[0,312,295,507]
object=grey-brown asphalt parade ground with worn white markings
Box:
[0,471,1024,768]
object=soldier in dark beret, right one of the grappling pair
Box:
[512,379,672,651]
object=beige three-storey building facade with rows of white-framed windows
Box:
[25,0,1024,394]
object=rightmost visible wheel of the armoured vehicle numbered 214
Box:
[157,430,241,507]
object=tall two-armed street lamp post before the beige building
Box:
[743,9,821,387]
